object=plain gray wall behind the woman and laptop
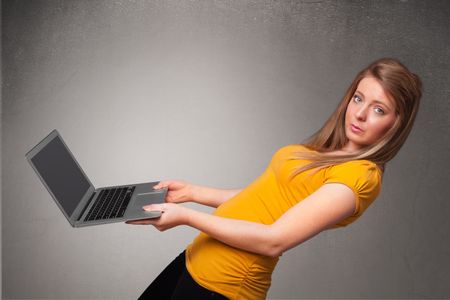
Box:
[1,0,450,299]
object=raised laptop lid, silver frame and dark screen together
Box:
[25,130,95,226]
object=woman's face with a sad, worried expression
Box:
[343,77,397,151]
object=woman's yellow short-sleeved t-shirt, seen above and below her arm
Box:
[186,145,381,300]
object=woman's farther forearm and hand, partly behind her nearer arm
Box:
[154,180,241,207]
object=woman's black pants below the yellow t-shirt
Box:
[138,252,227,300]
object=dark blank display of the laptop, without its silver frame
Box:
[31,136,90,217]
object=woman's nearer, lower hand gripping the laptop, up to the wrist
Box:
[126,203,191,231]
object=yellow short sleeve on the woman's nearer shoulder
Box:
[324,160,381,227]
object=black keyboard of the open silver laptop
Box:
[85,186,135,221]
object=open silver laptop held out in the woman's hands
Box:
[25,130,167,227]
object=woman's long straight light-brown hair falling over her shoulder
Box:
[293,58,422,176]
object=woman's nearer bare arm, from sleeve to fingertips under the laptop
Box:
[129,183,356,256]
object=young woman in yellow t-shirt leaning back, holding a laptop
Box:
[128,58,421,299]
